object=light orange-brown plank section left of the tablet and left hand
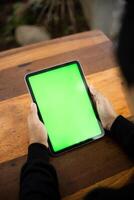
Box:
[0,95,30,163]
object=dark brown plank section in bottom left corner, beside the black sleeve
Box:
[0,157,26,200]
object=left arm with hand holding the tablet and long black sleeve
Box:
[20,104,60,200]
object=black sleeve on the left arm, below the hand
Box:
[20,143,60,200]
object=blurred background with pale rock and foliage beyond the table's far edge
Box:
[0,0,124,51]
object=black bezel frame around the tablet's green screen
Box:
[25,61,104,156]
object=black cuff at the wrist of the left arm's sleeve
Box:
[27,143,49,162]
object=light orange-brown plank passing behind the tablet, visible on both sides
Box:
[0,68,131,162]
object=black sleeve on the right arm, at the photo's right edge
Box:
[111,116,134,158]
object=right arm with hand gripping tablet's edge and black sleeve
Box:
[90,86,134,157]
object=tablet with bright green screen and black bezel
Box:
[25,61,104,155]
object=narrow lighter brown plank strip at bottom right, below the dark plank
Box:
[63,167,134,200]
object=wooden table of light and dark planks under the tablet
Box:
[0,31,134,200]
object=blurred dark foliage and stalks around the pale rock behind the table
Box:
[0,0,88,50]
